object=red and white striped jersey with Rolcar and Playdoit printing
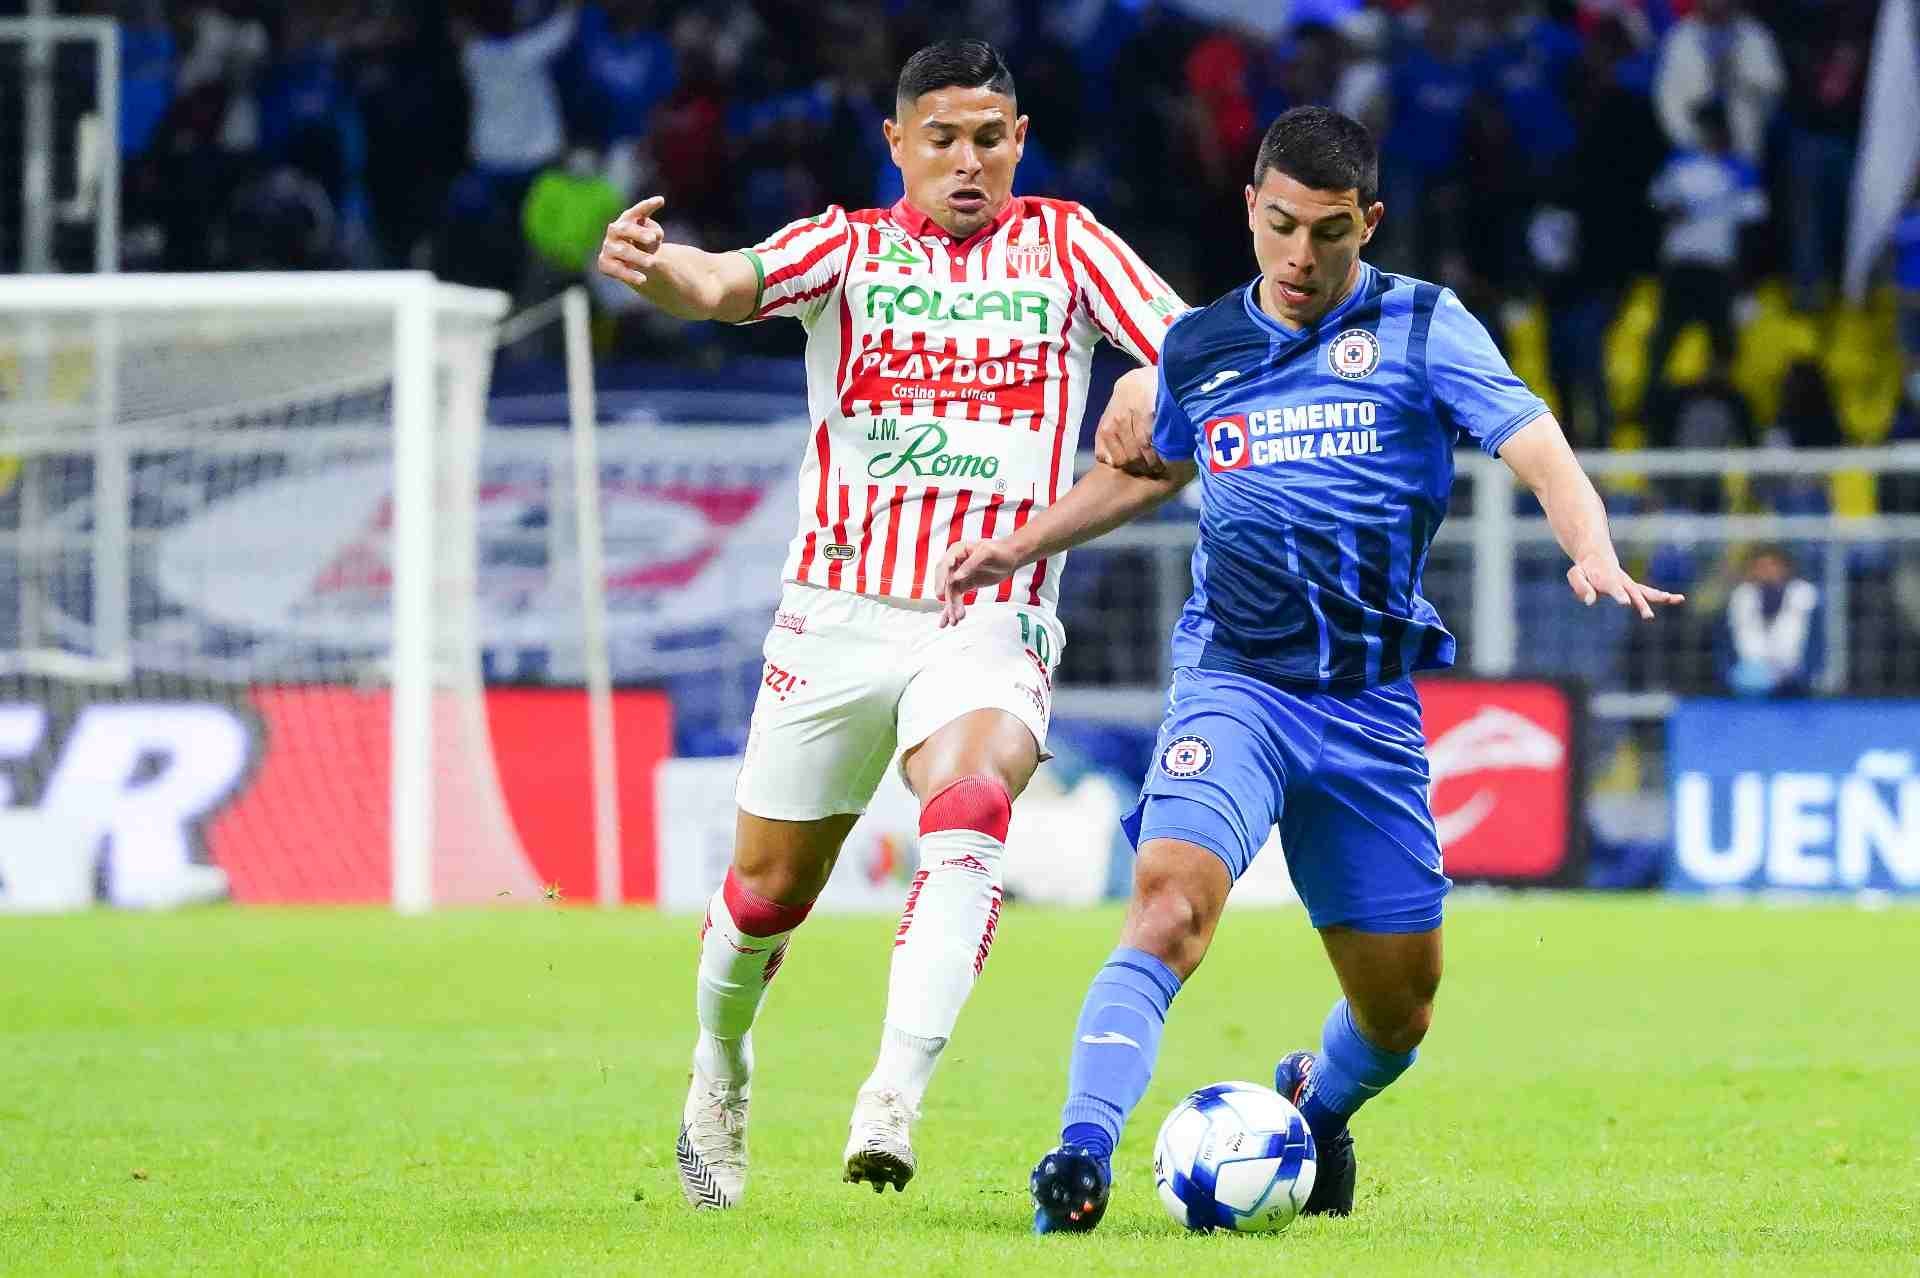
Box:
[745,196,1187,608]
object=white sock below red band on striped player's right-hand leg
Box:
[864,829,1006,1105]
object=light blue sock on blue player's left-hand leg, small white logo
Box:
[1060,946,1181,1159]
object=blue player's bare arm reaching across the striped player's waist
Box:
[933,461,1194,626]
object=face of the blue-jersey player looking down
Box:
[1246,169,1386,328]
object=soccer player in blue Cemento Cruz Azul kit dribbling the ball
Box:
[941,107,1682,1232]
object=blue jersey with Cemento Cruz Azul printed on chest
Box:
[1154,263,1548,691]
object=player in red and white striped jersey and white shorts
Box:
[599,40,1185,1207]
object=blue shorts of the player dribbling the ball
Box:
[1121,668,1453,933]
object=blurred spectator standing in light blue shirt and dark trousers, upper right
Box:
[1647,104,1766,388]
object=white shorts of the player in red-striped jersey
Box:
[735,581,1066,821]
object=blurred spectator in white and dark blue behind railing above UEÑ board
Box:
[1718,545,1826,697]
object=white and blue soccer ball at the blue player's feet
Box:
[1154,1082,1315,1234]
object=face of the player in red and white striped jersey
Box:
[885,88,1027,240]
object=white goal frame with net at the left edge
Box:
[0,272,586,910]
